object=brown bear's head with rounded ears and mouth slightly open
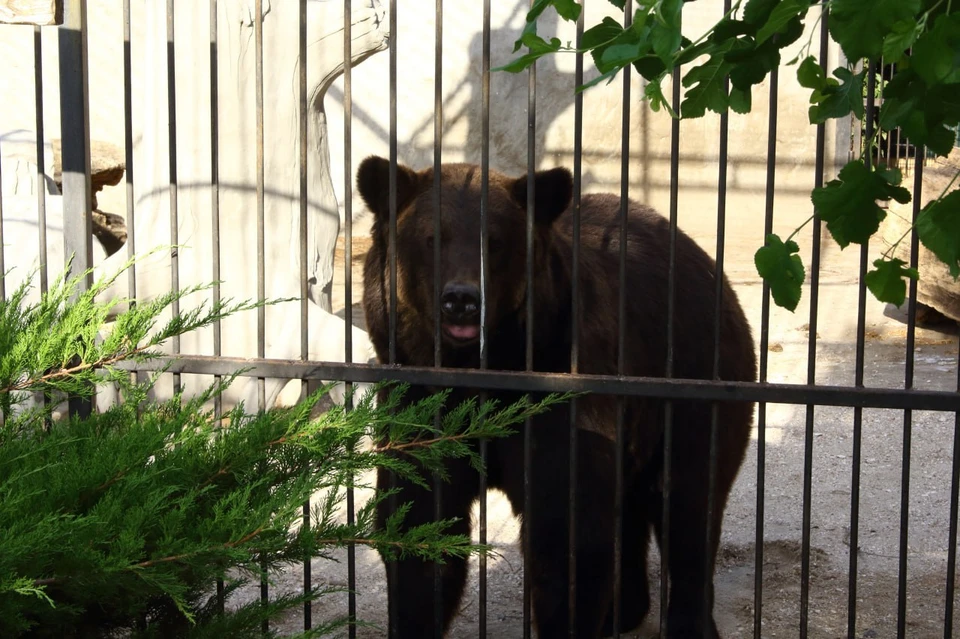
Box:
[357,156,573,349]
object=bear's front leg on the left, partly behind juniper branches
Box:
[377,460,479,639]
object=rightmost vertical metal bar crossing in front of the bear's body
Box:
[660,51,680,637]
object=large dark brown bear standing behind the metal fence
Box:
[357,157,757,639]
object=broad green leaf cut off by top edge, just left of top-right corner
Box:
[829,0,920,60]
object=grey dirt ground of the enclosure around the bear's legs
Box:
[251,219,960,639]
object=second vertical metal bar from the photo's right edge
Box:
[897,144,925,639]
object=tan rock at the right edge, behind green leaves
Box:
[880,148,960,322]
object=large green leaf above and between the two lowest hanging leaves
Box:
[811,160,910,249]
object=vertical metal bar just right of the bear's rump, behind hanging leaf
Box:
[753,63,780,639]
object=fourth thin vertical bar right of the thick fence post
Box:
[253,0,270,633]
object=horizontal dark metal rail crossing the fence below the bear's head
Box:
[116,355,960,412]
